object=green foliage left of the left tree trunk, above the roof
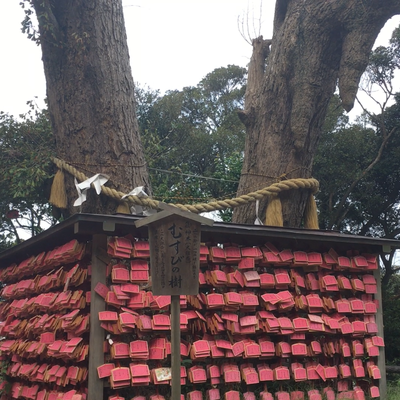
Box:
[0,102,55,249]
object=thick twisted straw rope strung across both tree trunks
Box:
[52,157,319,214]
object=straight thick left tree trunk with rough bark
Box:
[33,0,150,214]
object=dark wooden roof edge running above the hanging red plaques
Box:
[0,214,400,263]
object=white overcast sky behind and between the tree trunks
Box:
[0,0,400,115]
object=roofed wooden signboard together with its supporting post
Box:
[136,203,214,400]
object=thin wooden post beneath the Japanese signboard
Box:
[171,295,181,400]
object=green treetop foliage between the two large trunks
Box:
[136,65,246,220]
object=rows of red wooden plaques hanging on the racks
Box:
[0,237,383,400]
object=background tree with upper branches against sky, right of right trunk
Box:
[314,28,400,286]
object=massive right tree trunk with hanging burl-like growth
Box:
[233,0,400,227]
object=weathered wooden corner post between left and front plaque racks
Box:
[88,235,108,400]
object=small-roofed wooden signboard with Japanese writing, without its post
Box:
[136,205,213,296]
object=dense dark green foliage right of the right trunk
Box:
[314,94,400,237]
